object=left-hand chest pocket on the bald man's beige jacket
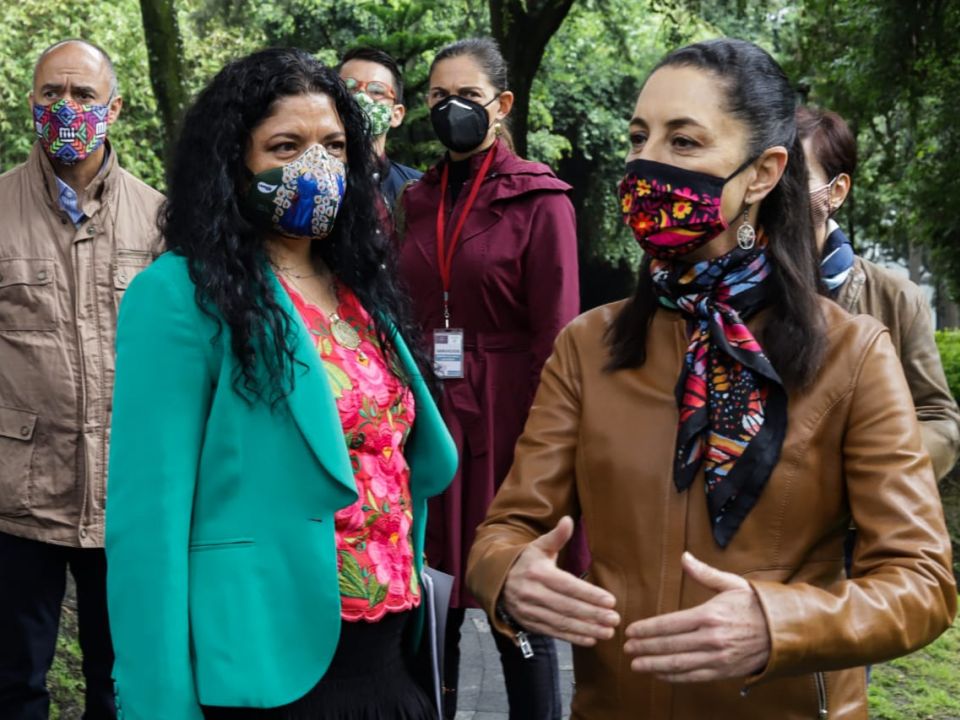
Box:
[0,258,57,332]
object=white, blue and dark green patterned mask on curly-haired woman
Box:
[243,145,347,240]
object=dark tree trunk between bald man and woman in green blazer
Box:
[140,0,187,147]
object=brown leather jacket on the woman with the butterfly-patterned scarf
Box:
[467,299,957,720]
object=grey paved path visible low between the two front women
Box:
[457,610,573,720]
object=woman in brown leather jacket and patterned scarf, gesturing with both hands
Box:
[467,39,957,720]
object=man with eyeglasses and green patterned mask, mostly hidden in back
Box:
[339,47,423,210]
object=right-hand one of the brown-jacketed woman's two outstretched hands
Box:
[624,552,770,682]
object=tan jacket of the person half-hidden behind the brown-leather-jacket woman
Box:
[837,257,960,480]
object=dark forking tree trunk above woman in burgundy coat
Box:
[489,0,573,157]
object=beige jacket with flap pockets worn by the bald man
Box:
[0,145,163,547]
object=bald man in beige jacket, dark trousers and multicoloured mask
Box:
[0,40,163,720]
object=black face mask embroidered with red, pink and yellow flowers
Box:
[619,159,753,259]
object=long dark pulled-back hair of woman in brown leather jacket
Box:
[608,38,826,389]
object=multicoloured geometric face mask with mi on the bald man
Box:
[33,98,110,165]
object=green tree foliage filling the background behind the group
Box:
[0,0,960,305]
